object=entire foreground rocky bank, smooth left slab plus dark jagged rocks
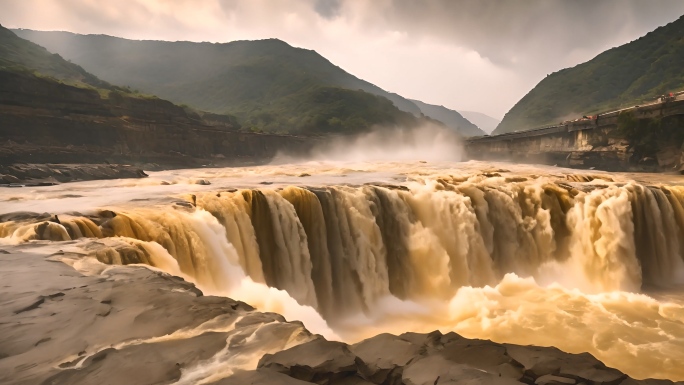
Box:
[0,242,672,385]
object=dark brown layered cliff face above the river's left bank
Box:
[0,70,311,166]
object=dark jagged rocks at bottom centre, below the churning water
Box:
[259,331,684,385]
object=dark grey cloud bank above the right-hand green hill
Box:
[346,0,684,66]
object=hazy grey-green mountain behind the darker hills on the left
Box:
[15,30,420,115]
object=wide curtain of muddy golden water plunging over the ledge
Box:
[0,177,684,319]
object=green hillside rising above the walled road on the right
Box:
[494,16,684,134]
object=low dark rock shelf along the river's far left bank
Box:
[0,163,147,187]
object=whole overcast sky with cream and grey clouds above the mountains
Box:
[0,0,684,119]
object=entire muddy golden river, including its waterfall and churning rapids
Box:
[0,162,684,380]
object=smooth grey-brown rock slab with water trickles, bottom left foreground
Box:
[0,247,312,384]
